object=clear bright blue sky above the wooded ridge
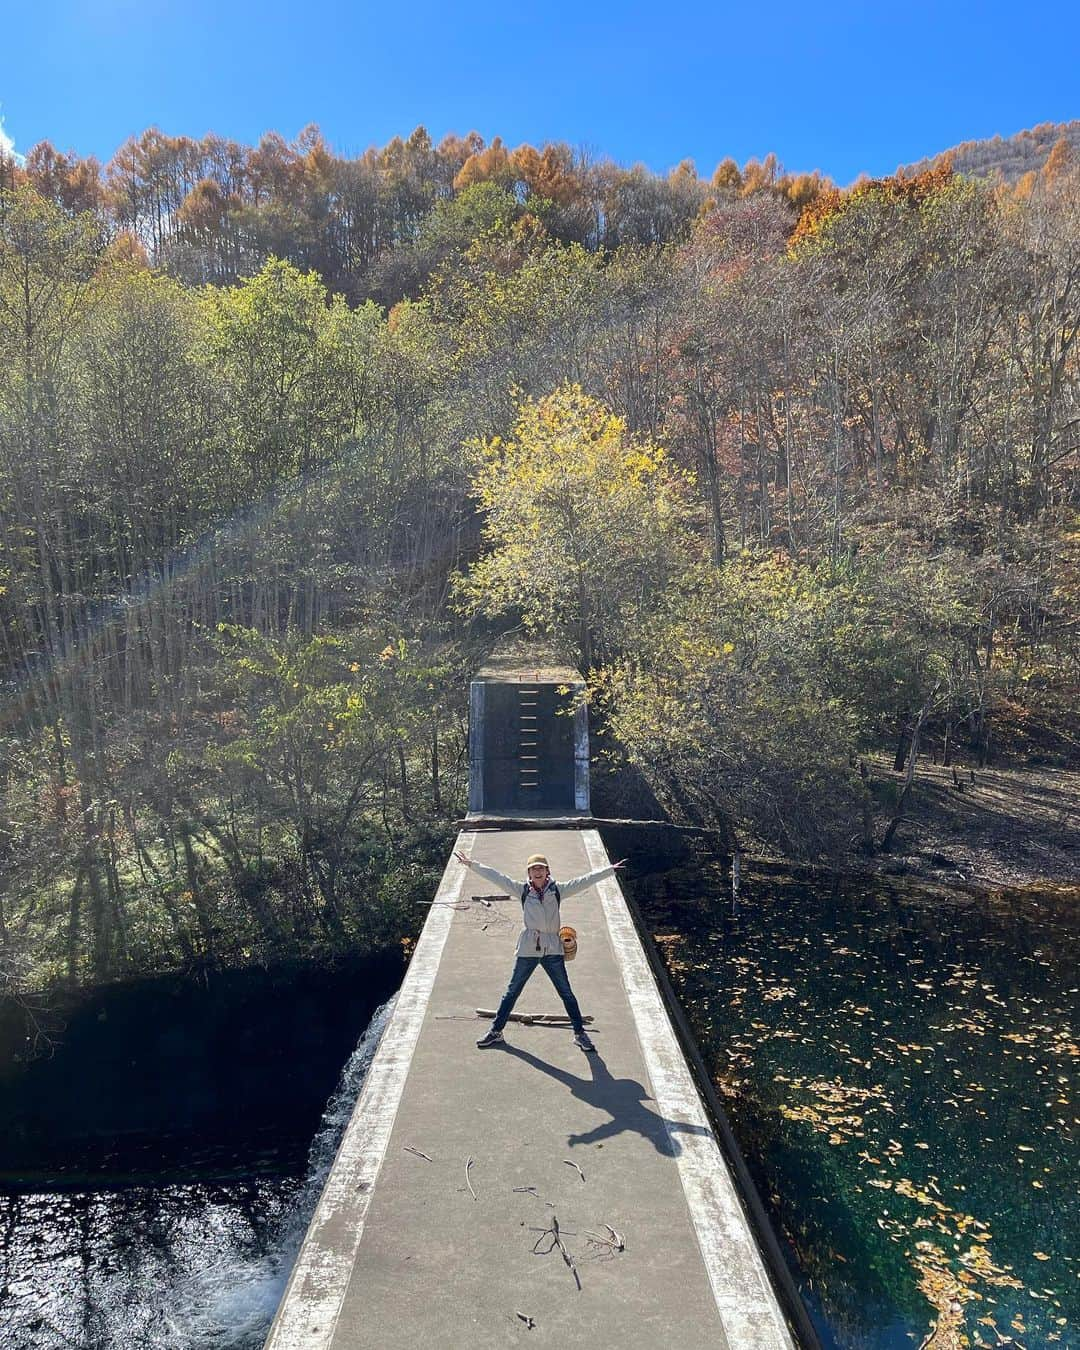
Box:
[0,0,1080,184]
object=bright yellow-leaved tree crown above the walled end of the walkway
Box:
[459,385,693,670]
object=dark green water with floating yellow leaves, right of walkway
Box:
[635,865,1080,1350]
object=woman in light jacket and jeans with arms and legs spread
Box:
[454,849,626,1050]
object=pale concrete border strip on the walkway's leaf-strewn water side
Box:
[582,830,795,1350]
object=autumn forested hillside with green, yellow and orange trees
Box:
[0,128,1080,986]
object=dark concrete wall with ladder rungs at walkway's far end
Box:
[468,651,589,817]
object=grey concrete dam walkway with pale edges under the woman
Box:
[266,828,795,1350]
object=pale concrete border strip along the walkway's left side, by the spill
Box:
[263,830,468,1350]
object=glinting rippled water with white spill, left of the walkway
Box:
[0,1000,393,1350]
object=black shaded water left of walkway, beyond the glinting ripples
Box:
[0,949,404,1192]
